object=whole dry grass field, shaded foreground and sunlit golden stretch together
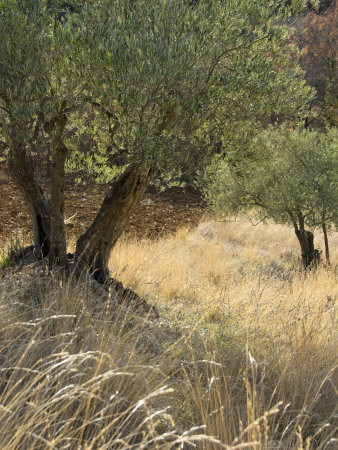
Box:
[0,221,338,449]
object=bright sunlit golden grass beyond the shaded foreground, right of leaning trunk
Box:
[111,221,338,338]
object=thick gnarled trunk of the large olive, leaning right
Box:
[75,165,153,283]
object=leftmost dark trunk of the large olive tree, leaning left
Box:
[8,143,51,256]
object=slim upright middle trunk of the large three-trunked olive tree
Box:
[48,114,68,265]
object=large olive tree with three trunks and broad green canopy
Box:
[0,0,311,282]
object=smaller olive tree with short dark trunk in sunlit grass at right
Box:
[205,127,338,268]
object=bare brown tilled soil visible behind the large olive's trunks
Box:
[0,180,207,247]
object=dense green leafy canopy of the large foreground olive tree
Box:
[0,0,309,169]
